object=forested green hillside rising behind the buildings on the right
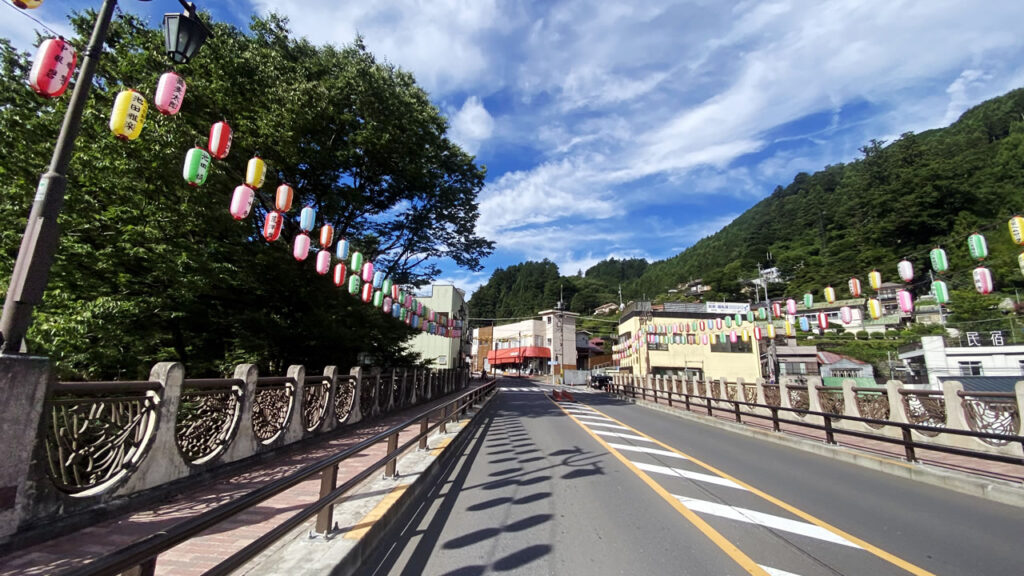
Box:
[471,89,1024,323]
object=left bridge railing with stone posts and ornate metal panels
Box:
[9,362,469,542]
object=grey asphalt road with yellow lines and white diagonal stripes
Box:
[364,380,1024,576]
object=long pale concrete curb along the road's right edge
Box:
[609,395,1024,507]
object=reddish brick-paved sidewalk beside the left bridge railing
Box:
[0,381,491,576]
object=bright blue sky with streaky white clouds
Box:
[6,0,1024,293]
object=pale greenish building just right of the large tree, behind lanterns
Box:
[410,284,471,368]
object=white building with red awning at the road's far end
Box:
[472,310,580,374]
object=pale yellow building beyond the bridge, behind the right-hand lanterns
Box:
[613,302,764,382]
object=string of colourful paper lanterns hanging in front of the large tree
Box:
[22,16,463,338]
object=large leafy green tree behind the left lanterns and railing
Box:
[0,13,493,378]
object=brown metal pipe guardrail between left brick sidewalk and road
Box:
[62,380,496,576]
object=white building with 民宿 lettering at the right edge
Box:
[897,330,1024,390]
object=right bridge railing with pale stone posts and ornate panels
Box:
[611,374,1024,465]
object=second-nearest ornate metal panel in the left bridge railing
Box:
[174,379,245,464]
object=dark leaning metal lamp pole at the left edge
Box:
[0,0,117,354]
